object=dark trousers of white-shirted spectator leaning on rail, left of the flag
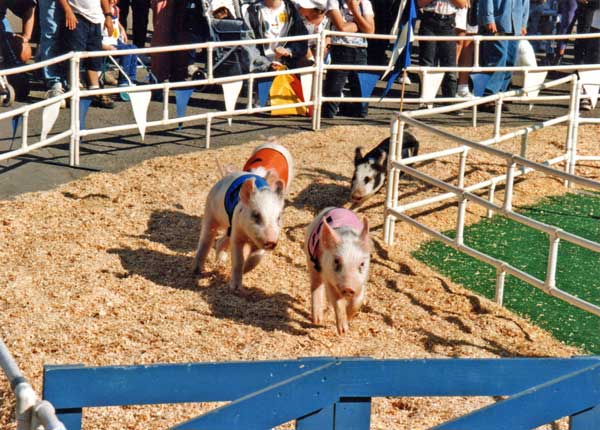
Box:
[322,45,367,118]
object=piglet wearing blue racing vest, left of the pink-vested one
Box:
[193,172,284,293]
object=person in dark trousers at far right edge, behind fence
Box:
[575,0,600,111]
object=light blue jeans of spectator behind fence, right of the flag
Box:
[481,40,517,96]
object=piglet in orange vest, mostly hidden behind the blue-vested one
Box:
[243,139,294,191]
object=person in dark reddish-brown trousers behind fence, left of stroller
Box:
[150,0,175,82]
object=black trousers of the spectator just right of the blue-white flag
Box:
[419,12,458,97]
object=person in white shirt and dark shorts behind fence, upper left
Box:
[59,0,114,109]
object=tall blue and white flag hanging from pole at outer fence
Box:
[382,0,417,98]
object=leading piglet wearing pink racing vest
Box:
[304,207,371,335]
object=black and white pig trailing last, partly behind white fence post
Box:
[350,131,419,203]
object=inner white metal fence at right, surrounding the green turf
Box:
[384,75,600,316]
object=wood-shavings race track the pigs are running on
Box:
[0,120,600,430]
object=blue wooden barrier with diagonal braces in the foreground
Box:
[44,357,600,430]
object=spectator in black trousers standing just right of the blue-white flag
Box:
[417,0,467,101]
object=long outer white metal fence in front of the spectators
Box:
[0,31,600,165]
